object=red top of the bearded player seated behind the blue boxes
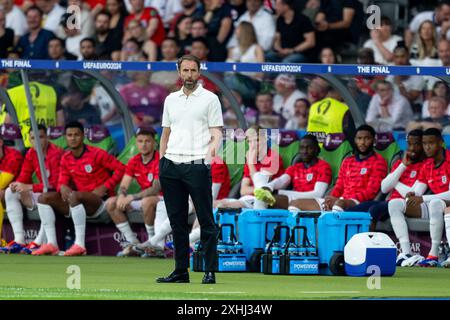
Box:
[331,152,387,202]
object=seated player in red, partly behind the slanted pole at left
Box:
[2,125,64,254]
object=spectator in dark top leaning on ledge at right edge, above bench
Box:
[408,96,450,131]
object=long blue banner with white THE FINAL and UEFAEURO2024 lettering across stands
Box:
[0,59,450,76]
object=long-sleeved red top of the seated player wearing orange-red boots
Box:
[58,145,125,196]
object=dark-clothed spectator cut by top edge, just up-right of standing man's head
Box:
[202,0,233,61]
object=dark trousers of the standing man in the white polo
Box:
[159,157,218,271]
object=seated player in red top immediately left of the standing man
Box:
[106,128,162,256]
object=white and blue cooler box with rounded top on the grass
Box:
[344,232,397,277]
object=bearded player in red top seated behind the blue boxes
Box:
[290,125,387,211]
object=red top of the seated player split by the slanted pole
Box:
[17,143,64,192]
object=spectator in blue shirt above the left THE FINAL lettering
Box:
[17,6,55,59]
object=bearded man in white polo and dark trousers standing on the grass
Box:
[156,55,223,284]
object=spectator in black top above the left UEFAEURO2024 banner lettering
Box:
[94,11,122,60]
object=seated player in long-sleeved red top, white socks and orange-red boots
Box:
[32,121,125,256]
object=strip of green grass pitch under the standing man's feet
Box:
[0,255,450,300]
